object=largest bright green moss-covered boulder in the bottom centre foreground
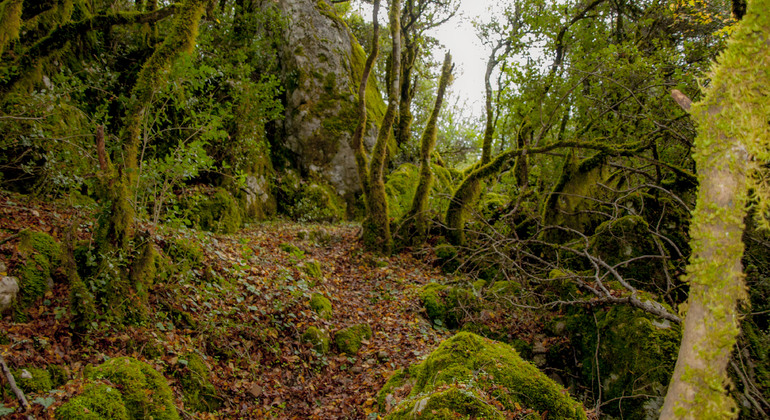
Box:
[378,332,586,419]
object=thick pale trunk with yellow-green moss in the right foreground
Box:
[661,0,770,419]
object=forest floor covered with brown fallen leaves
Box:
[0,193,456,419]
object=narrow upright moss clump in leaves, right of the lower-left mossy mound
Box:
[176,353,221,412]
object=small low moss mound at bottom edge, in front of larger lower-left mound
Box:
[56,384,129,420]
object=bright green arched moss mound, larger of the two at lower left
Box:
[87,357,179,420]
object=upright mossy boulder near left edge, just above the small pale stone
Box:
[14,231,61,320]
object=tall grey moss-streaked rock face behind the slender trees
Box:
[275,0,385,199]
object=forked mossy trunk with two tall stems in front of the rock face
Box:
[351,0,401,254]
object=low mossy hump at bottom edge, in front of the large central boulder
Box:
[385,386,505,420]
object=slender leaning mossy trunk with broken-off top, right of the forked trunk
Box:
[406,52,454,243]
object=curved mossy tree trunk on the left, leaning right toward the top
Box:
[86,0,206,321]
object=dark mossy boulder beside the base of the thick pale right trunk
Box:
[557,305,681,419]
